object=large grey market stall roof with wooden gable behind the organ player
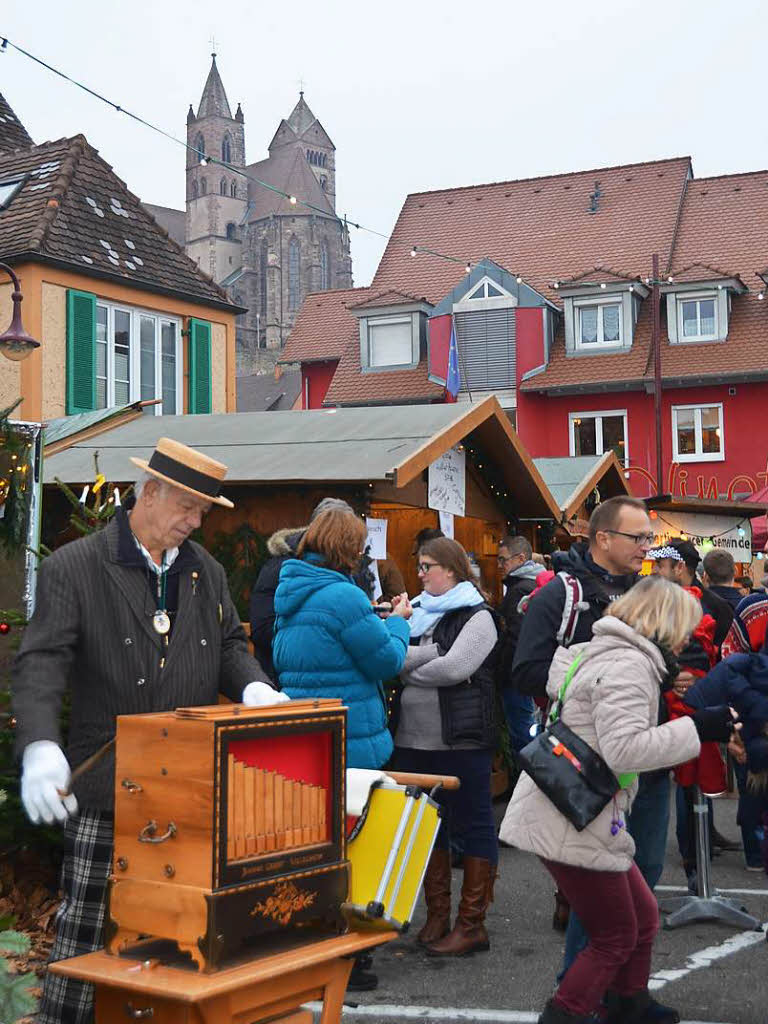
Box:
[45,396,560,519]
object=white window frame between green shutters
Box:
[96,299,184,416]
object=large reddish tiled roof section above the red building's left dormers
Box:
[372,157,690,302]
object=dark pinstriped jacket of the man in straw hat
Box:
[12,518,265,811]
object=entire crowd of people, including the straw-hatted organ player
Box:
[13,438,768,1024]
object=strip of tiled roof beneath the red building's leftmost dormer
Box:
[323,342,445,406]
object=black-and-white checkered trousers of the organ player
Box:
[37,810,114,1024]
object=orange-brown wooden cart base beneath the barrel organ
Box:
[48,932,397,1024]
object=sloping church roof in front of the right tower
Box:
[246,142,336,221]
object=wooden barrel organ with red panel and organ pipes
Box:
[108,700,349,971]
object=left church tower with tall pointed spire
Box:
[186,53,248,283]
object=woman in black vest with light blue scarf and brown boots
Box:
[394,537,499,956]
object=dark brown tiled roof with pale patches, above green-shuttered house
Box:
[0,135,231,308]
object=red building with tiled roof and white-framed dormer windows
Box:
[285,158,768,499]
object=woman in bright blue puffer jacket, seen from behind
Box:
[272,509,411,768]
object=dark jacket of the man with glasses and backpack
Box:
[512,544,637,696]
